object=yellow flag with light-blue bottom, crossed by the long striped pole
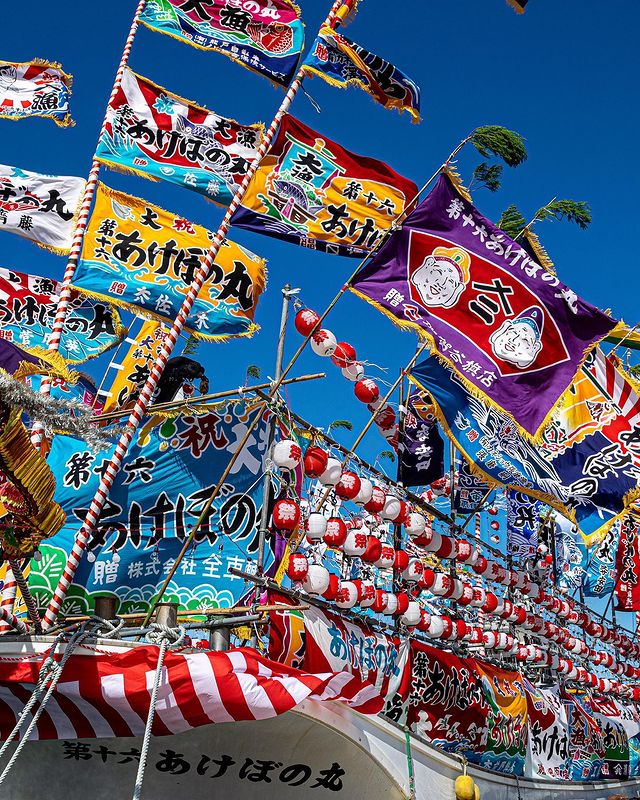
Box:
[74,184,266,341]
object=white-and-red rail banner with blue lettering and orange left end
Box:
[269,594,411,723]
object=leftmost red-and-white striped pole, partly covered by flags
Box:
[31,0,147,447]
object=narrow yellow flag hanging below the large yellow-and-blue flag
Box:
[100,320,168,412]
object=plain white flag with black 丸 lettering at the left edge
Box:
[0,164,86,255]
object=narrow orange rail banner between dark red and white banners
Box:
[471,659,527,775]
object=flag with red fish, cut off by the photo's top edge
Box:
[140,0,304,86]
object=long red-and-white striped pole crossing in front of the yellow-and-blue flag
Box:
[43,0,344,630]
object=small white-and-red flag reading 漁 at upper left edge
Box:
[0,58,74,128]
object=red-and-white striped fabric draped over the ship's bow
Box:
[0,646,383,741]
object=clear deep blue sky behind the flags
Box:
[0,0,640,620]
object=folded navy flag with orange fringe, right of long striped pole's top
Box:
[301,27,420,122]
